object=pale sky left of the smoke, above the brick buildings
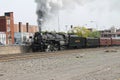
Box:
[0,0,37,25]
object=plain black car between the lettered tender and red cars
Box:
[86,38,100,48]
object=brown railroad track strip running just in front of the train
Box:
[0,47,120,62]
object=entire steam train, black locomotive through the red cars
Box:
[31,32,120,52]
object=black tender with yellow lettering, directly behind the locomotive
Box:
[68,35,85,48]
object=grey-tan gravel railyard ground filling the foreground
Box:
[0,47,120,80]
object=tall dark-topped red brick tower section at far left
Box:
[0,12,14,44]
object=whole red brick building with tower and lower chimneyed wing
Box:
[0,12,38,44]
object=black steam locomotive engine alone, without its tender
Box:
[32,32,68,52]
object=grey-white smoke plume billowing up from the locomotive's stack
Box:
[35,0,93,30]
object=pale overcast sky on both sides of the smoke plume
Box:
[0,0,120,31]
